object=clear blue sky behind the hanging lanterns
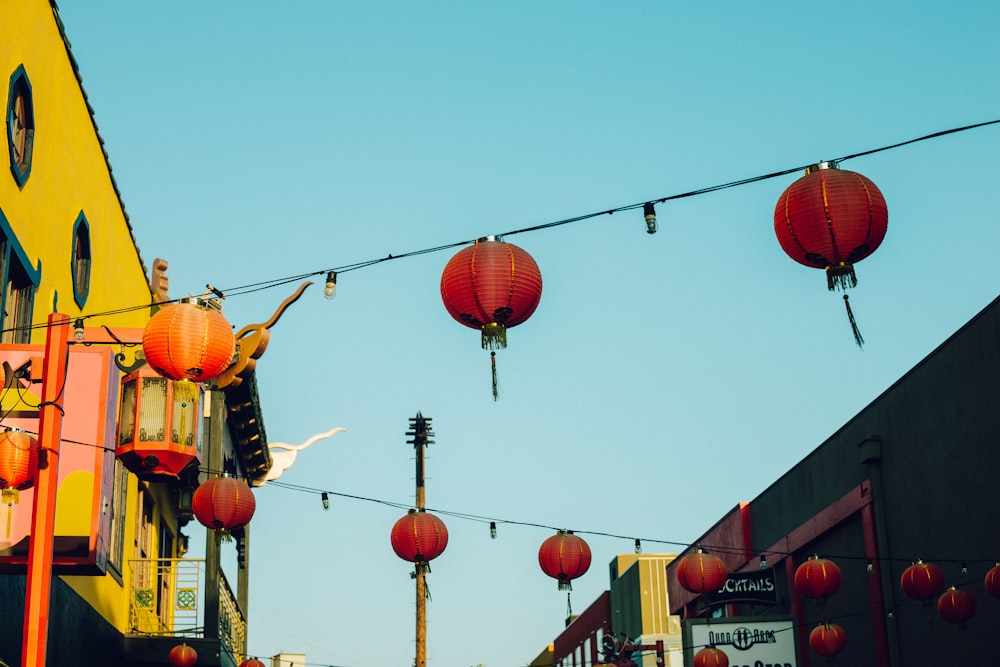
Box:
[60,0,1000,667]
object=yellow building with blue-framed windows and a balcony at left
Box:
[0,0,271,666]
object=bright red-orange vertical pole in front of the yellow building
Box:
[21,313,69,667]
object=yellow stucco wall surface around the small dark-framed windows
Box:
[0,0,159,632]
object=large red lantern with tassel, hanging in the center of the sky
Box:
[441,236,542,399]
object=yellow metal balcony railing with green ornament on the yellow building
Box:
[129,558,247,656]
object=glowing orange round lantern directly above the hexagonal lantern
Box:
[142,298,236,382]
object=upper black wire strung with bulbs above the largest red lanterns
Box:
[0,119,1000,333]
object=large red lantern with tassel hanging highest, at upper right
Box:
[774,162,889,345]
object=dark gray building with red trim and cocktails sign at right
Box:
[667,299,1000,667]
